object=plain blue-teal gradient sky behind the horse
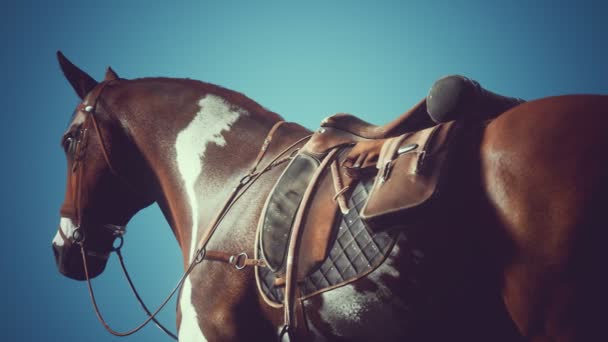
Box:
[0,1,608,342]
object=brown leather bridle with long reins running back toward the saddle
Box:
[59,81,310,340]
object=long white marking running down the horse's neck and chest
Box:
[175,95,247,341]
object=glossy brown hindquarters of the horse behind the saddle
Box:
[481,95,608,341]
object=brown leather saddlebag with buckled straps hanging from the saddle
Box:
[361,121,460,231]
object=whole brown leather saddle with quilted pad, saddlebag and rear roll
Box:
[255,76,522,316]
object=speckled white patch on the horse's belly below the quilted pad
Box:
[319,245,399,336]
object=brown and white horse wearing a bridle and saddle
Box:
[52,53,608,342]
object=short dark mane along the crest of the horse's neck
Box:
[129,77,283,120]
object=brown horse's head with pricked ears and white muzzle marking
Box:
[52,53,152,280]
